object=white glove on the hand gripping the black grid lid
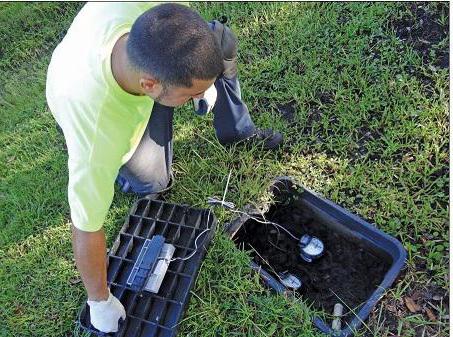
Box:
[87,289,126,333]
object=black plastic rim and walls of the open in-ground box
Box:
[226,177,406,337]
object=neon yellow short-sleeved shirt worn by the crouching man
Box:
[46,2,158,232]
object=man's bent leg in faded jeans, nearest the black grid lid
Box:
[117,102,174,195]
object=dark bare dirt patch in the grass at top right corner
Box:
[390,2,449,68]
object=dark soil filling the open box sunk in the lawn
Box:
[234,200,390,321]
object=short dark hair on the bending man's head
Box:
[126,3,223,87]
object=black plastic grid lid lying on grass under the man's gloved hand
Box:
[79,198,217,337]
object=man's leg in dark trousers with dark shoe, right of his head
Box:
[209,20,283,148]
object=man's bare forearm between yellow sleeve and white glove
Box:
[71,225,109,301]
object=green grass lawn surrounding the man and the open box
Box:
[0,2,449,337]
